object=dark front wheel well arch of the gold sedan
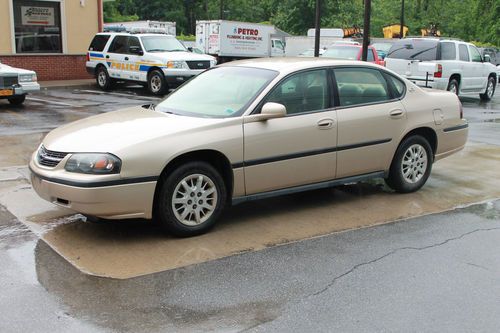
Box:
[153,149,233,211]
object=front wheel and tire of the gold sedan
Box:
[155,162,227,237]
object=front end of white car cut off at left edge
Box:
[0,62,40,105]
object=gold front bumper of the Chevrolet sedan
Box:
[29,160,156,219]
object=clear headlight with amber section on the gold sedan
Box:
[64,153,122,174]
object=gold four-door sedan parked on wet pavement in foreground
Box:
[30,58,468,236]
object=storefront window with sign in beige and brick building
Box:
[13,0,62,53]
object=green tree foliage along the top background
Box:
[104,0,500,46]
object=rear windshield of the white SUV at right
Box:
[387,39,438,61]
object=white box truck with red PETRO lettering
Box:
[196,20,285,63]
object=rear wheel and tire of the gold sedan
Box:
[385,135,434,193]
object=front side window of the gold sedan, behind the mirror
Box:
[264,69,328,114]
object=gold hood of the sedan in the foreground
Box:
[43,106,224,153]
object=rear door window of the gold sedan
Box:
[334,68,390,106]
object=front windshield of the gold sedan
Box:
[155,67,278,118]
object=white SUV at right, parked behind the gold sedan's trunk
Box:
[385,38,498,100]
